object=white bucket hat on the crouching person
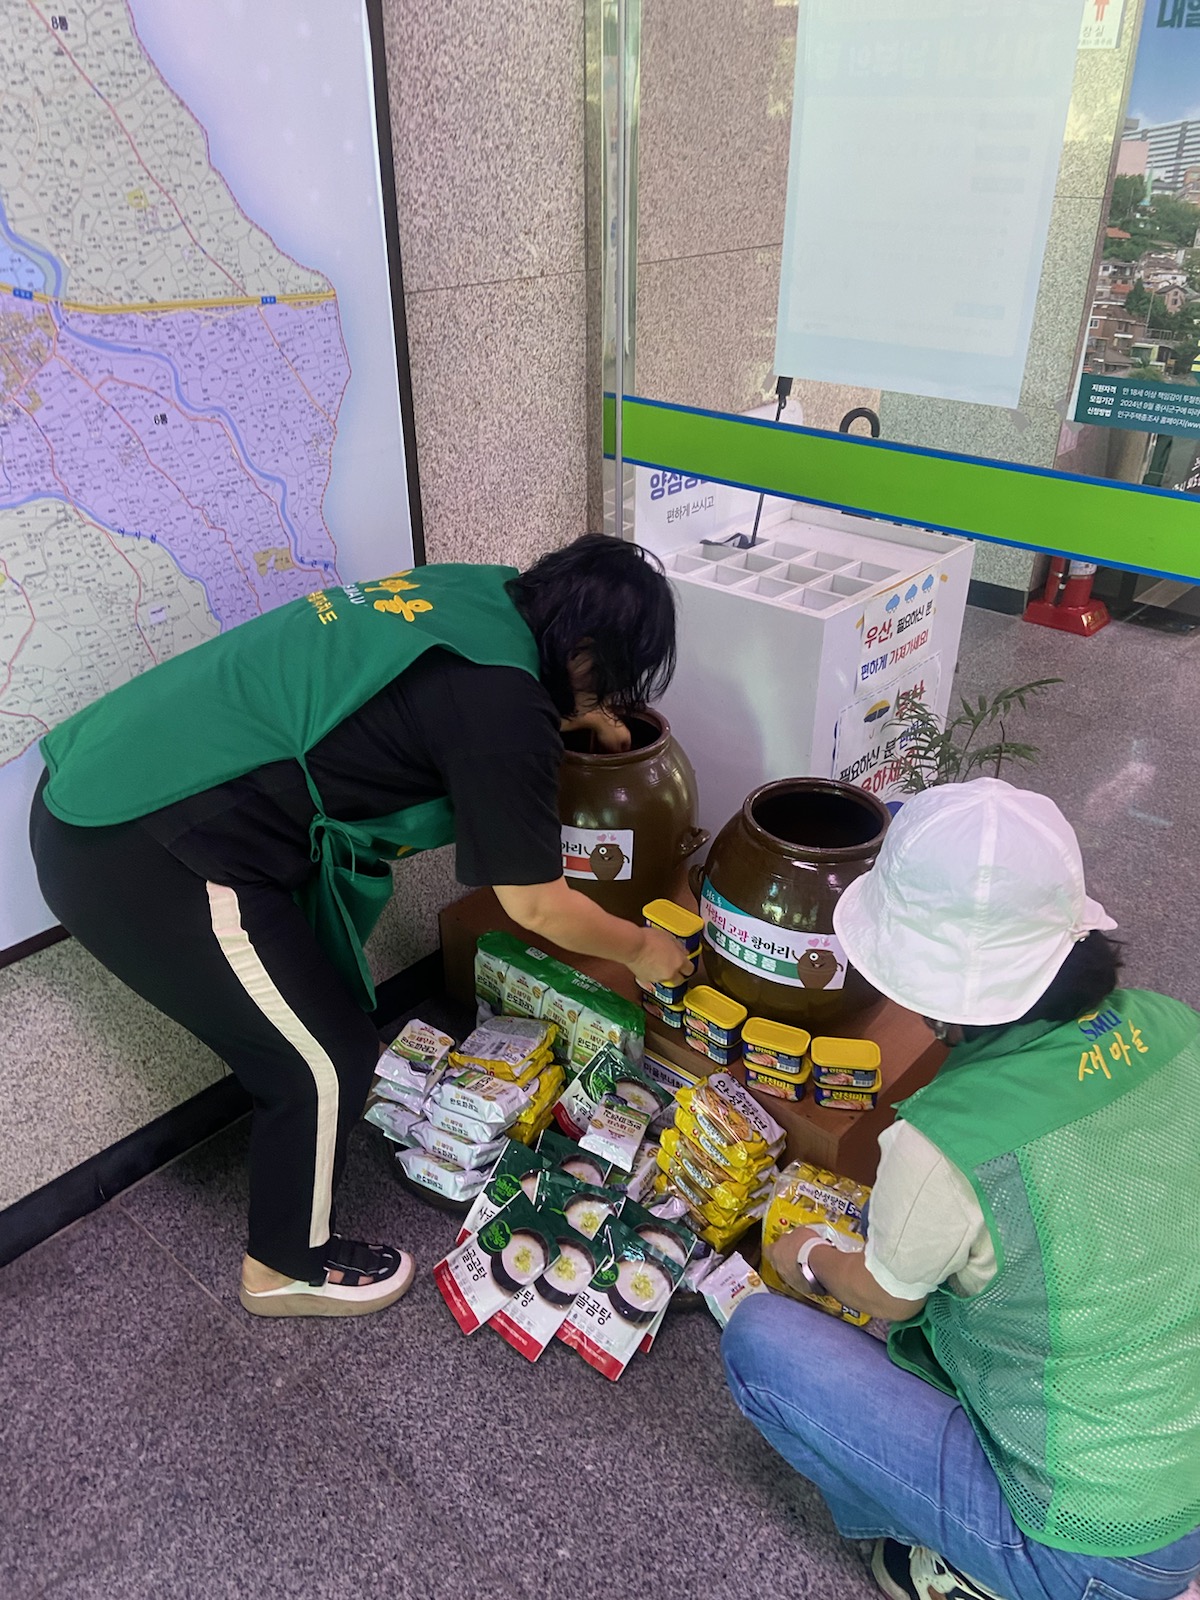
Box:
[834,778,1117,1026]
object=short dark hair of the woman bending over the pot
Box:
[509,533,675,717]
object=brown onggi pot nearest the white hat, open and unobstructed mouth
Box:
[693,778,888,1032]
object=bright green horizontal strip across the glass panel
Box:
[605,395,1200,582]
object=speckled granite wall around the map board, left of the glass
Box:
[0,0,587,1208]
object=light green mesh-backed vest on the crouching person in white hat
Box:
[888,989,1200,1557]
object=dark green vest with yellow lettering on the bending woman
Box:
[42,565,538,1010]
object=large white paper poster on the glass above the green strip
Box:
[774,0,1094,406]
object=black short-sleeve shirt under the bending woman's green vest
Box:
[141,650,563,890]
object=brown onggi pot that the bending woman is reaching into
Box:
[558,709,709,922]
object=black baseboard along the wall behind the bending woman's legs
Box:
[0,950,442,1267]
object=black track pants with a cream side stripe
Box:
[29,789,379,1280]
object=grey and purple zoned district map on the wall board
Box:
[0,0,350,766]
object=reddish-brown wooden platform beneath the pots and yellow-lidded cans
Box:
[440,890,946,1184]
